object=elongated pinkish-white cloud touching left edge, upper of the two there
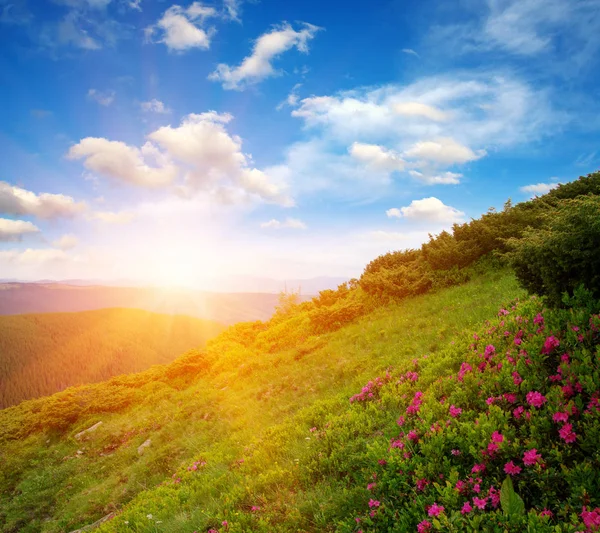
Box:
[0,181,86,218]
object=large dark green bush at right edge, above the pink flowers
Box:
[509,196,600,306]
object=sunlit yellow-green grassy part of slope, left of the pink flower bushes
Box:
[0,271,523,533]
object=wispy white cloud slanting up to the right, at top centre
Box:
[208,23,320,90]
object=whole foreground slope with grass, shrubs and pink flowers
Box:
[0,173,600,533]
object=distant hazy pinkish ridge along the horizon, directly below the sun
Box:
[0,282,310,324]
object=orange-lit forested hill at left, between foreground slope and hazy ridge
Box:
[0,309,224,408]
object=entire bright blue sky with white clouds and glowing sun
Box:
[0,0,600,285]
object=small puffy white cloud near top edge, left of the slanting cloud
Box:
[144,2,217,52]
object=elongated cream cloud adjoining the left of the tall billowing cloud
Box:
[67,137,178,187]
